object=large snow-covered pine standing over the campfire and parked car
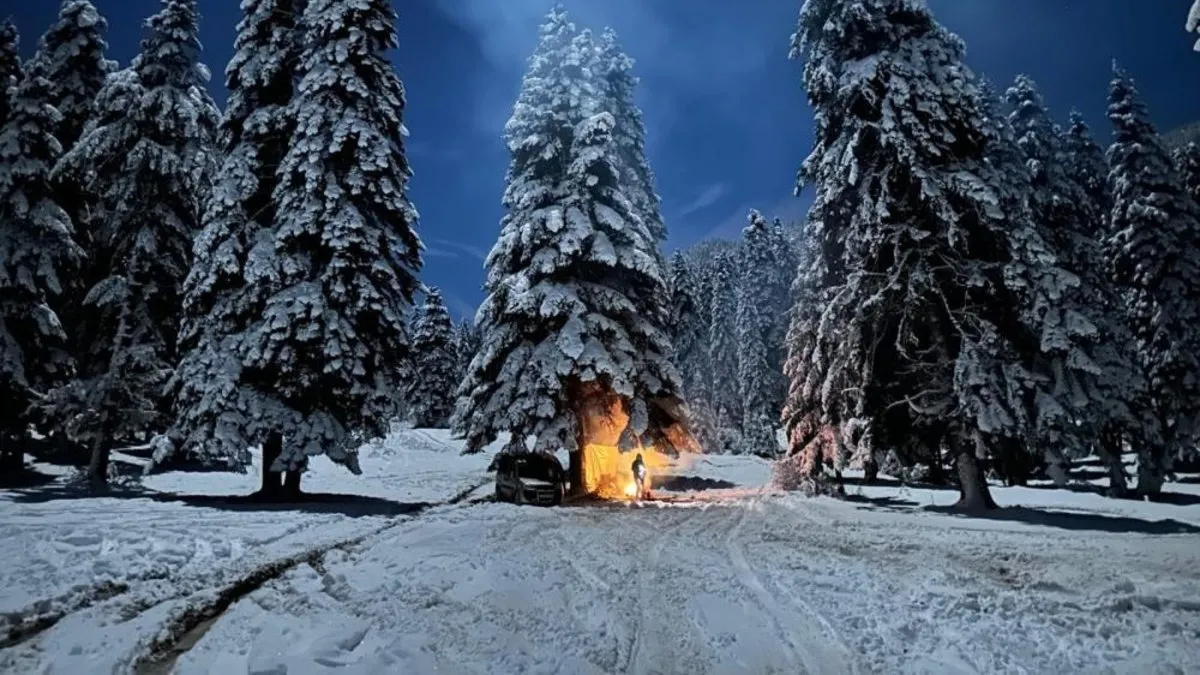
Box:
[452,11,684,490]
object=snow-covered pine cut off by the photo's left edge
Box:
[0,64,83,477]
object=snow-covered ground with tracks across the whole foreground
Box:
[0,430,1200,675]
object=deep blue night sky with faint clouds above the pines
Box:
[9,0,1200,316]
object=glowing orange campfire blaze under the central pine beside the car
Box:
[582,389,700,501]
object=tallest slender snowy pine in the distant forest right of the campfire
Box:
[736,210,784,456]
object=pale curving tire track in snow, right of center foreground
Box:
[725,500,858,675]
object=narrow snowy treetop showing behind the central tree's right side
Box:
[599,28,667,246]
